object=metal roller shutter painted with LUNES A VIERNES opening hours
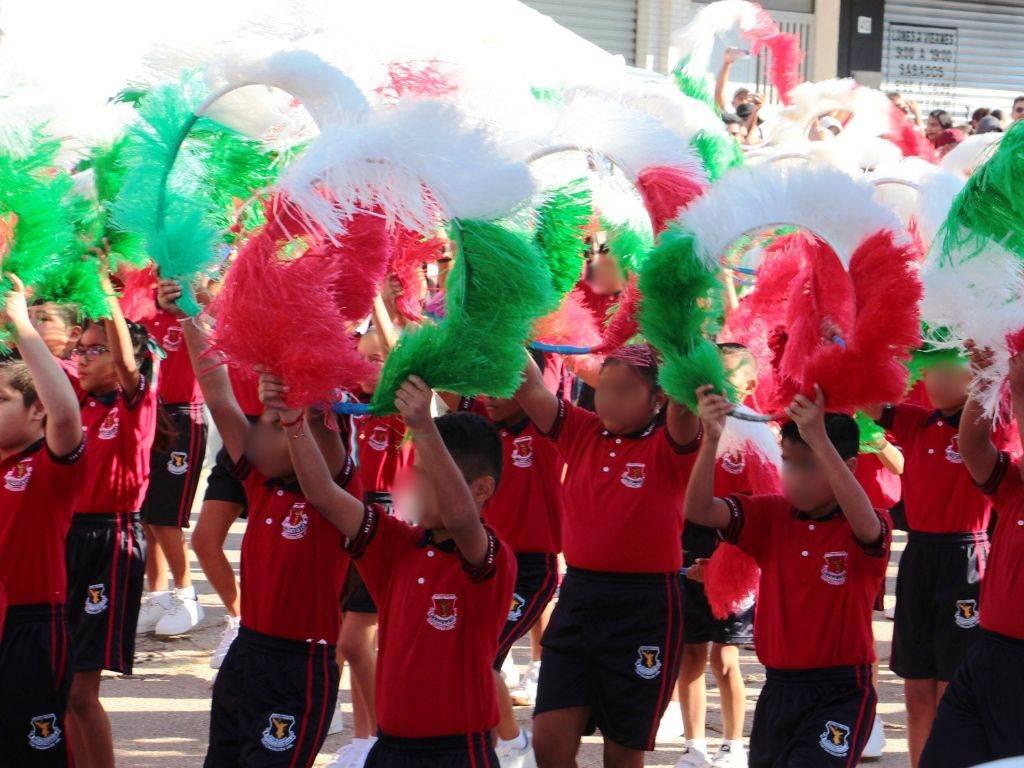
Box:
[882,0,1024,121]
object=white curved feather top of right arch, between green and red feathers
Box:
[678,164,906,267]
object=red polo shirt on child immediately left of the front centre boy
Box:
[234,459,361,645]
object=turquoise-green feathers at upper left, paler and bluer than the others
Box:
[113,70,221,314]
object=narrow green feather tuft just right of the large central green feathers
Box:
[534,179,593,305]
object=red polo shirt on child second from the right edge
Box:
[880,403,992,534]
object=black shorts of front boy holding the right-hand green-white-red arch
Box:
[750,665,878,768]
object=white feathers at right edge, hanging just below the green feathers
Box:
[921,242,1024,419]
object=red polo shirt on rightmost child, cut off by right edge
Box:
[979,453,1024,640]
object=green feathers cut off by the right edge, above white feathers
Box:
[942,120,1024,263]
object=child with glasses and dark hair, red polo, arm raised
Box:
[67,270,157,766]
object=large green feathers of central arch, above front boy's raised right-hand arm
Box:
[371,220,553,415]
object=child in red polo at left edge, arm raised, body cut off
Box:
[0,276,85,766]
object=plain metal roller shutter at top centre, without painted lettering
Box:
[523,0,637,65]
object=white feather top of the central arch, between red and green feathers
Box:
[281,98,534,232]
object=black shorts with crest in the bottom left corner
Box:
[0,605,72,768]
